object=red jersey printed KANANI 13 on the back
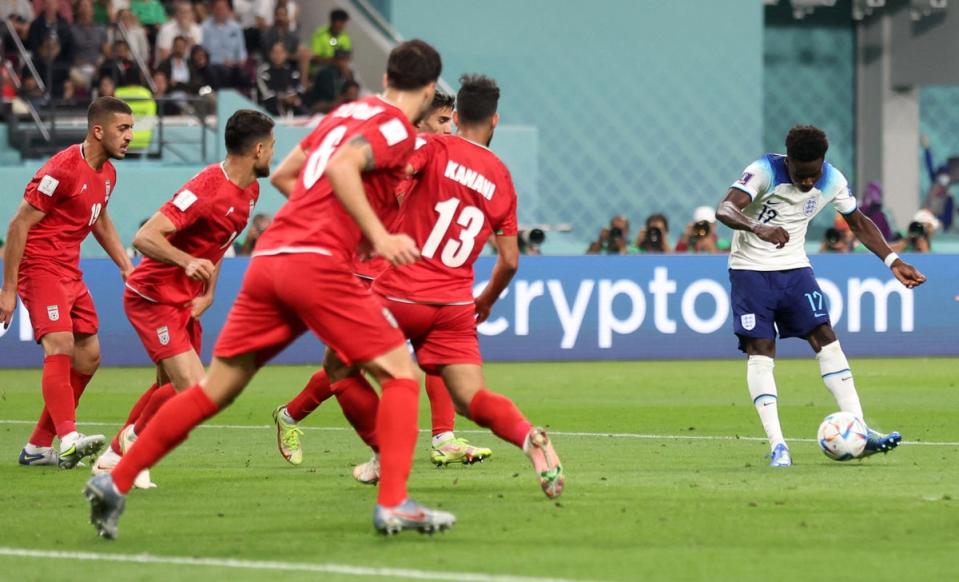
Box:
[373,135,516,304]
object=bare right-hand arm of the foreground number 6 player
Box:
[325,135,420,266]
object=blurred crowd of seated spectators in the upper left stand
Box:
[0,0,360,115]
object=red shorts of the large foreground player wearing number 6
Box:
[213,253,405,365]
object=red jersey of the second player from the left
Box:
[127,164,260,305]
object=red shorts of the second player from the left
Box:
[123,287,203,364]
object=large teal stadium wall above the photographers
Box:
[387,0,763,239]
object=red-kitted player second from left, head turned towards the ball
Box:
[93,109,276,488]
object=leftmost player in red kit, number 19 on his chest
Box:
[0,97,133,469]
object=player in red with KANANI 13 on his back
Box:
[356,75,566,497]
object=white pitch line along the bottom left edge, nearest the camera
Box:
[0,546,584,582]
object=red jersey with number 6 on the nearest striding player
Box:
[253,97,415,269]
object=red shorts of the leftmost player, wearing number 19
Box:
[17,269,100,343]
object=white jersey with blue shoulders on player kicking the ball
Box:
[729,154,856,271]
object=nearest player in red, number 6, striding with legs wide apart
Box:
[84,40,455,538]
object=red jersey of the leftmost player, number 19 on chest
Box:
[20,145,117,279]
